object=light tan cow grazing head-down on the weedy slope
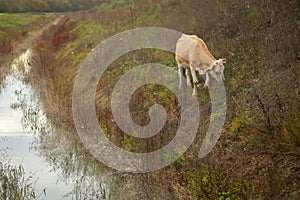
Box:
[175,34,226,96]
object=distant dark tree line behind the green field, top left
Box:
[0,0,128,13]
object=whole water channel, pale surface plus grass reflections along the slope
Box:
[0,50,113,199]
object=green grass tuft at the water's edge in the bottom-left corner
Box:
[0,162,46,200]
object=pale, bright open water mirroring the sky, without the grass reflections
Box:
[0,50,78,199]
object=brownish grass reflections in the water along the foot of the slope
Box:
[9,65,108,199]
